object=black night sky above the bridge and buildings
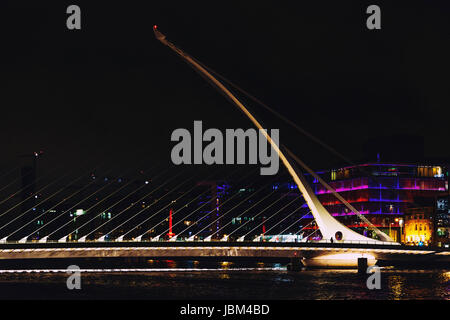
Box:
[0,0,450,175]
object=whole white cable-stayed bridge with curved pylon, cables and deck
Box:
[0,26,450,268]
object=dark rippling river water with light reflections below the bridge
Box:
[0,260,450,300]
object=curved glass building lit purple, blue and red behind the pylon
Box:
[302,163,448,240]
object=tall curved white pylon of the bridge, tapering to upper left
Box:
[153,26,394,244]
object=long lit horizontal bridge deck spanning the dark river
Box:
[0,241,444,259]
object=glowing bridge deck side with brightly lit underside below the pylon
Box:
[0,242,450,267]
